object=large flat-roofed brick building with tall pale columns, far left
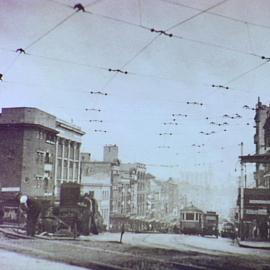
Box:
[0,107,84,197]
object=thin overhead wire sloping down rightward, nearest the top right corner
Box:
[159,0,270,30]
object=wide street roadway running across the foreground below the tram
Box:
[0,233,270,270]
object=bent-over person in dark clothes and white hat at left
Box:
[20,195,41,236]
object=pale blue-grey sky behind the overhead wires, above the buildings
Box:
[0,0,270,193]
